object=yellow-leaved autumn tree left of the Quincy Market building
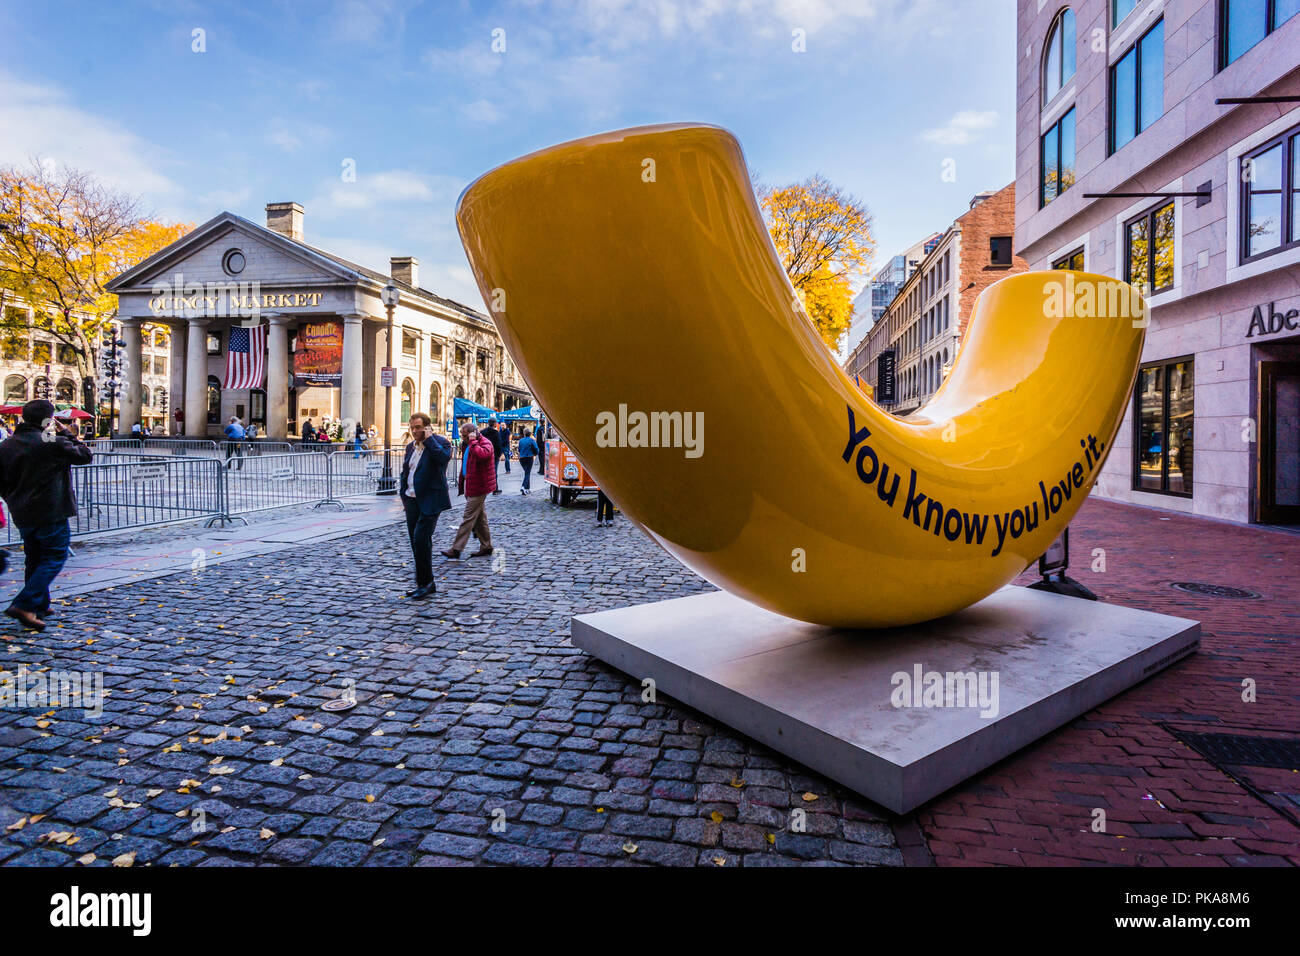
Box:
[0,160,192,403]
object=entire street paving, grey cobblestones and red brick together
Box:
[0,494,1300,866]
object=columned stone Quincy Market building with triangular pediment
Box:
[108,203,532,440]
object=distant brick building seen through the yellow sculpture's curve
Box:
[848,183,1028,415]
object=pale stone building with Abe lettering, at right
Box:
[1015,0,1300,524]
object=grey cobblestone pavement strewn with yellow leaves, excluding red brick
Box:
[0,483,909,866]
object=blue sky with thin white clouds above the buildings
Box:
[0,0,1015,307]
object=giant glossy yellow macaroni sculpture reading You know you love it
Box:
[456,126,1145,627]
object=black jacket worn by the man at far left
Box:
[0,421,94,528]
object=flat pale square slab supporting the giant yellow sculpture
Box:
[572,585,1201,813]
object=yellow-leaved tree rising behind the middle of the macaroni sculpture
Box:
[759,176,875,351]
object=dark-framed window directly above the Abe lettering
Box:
[1240,125,1300,261]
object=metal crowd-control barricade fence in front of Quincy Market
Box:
[4,440,408,544]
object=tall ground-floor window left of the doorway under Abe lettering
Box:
[1134,358,1193,498]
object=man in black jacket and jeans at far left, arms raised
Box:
[0,399,94,631]
